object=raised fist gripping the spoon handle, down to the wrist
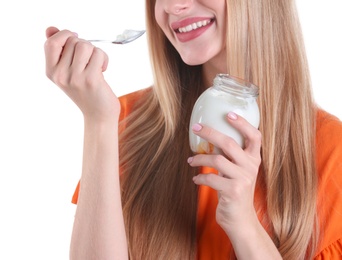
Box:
[44,27,120,122]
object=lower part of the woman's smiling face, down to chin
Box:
[155,0,226,65]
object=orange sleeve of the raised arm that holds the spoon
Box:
[71,88,150,204]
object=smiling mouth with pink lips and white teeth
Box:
[171,17,214,42]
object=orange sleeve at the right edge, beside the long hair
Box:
[315,110,342,260]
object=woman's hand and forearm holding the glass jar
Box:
[188,112,282,259]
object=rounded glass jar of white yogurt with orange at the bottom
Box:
[189,74,260,154]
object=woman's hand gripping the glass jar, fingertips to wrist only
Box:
[188,113,261,236]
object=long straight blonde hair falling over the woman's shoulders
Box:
[120,0,318,259]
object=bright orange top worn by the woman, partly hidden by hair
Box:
[72,91,342,260]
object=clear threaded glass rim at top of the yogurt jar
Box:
[214,73,259,97]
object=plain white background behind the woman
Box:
[0,0,342,260]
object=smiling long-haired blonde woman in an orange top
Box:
[45,0,342,259]
